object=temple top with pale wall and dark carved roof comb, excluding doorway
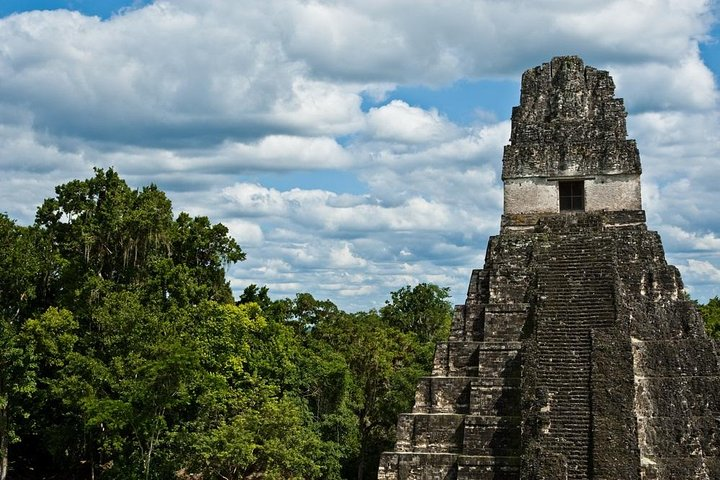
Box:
[503,57,642,214]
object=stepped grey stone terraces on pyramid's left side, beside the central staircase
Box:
[378,236,530,480]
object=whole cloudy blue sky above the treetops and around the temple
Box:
[0,0,720,310]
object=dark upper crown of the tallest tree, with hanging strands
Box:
[36,169,245,316]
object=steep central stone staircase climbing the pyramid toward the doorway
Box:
[535,234,615,480]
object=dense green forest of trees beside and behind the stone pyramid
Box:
[0,169,720,480]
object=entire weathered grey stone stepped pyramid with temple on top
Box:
[378,57,720,480]
